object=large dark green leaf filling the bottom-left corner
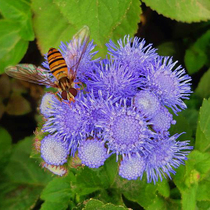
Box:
[0,137,51,210]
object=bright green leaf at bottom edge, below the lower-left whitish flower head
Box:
[41,172,75,210]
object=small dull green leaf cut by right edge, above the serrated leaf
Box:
[195,69,210,98]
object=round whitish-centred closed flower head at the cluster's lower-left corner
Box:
[41,135,69,166]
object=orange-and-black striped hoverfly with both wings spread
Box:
[5,26,89,102]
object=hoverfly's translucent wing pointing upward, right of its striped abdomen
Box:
[67,26,90,75]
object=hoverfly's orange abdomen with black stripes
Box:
[47,48,68,80]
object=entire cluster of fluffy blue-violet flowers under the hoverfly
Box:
[40,36,192,183]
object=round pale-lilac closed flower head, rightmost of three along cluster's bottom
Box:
[119,153,146,180]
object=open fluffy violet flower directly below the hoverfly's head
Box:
[43,93,89,154]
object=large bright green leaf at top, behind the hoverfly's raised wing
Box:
[32,0,141,57]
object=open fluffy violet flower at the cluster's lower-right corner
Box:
[146,134,193,183]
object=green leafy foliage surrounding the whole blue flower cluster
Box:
[0,0,210,210]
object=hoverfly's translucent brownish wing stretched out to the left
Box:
[5,64,55,87]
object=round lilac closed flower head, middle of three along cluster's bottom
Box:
[78,138,109,168]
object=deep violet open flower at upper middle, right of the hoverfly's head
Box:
[86,59,142,98]
